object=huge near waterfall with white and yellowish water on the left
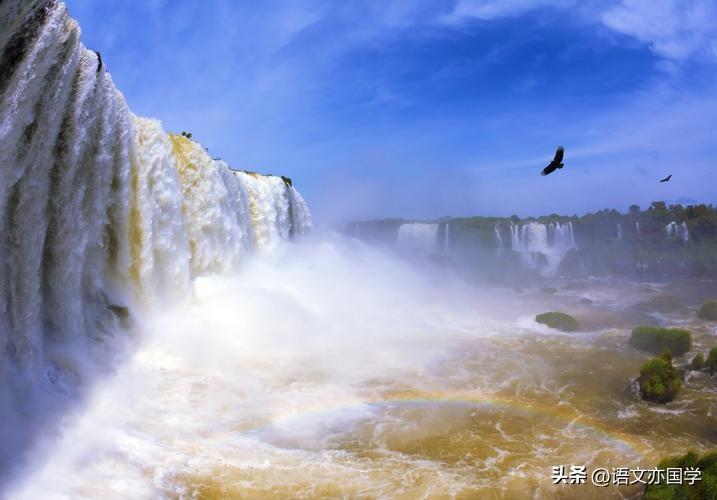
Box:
[0,0,311,471]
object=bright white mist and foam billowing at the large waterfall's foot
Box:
[5,234,490,498]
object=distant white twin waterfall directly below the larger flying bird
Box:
[510,222,576,275]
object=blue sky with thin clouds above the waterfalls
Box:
[67,0,717,222]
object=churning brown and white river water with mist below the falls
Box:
[11,239,717,499]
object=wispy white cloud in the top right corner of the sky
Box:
[602,0,717,60]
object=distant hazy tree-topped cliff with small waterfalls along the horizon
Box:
[346,202,717,277]
